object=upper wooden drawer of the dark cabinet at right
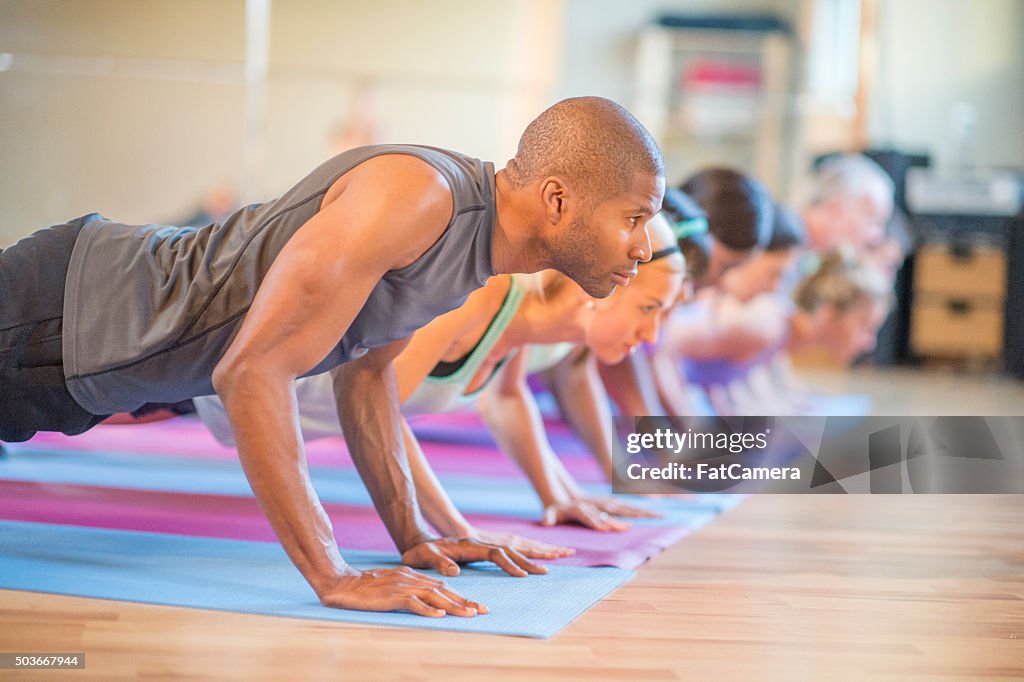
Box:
[913,245,1007,298]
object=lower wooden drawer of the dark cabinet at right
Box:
[910,298,1002,356]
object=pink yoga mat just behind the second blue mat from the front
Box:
[30,415,604,483]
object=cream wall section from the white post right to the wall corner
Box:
[258,0,561,199]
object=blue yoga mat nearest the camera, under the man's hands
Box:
[0,521,633,639]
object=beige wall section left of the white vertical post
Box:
[0,0,244,246]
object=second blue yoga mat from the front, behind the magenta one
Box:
[0,444,739,518]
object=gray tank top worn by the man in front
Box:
[62,144,495,415]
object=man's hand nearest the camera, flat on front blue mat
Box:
[319,566,487,619]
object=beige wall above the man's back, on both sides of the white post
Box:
[0,0,562,247]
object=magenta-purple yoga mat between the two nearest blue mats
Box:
[0,480,690,569]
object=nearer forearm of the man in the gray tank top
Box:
[218,375,350,595]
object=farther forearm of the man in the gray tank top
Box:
[335,361,432,552]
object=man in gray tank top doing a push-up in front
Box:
[0,97,665,616]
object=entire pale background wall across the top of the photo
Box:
[6,0,1024,247]
